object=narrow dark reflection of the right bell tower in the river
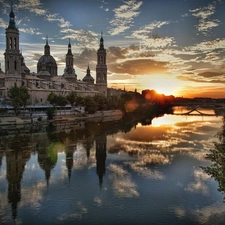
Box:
[95,134,106,187]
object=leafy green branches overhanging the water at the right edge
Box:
[201,116,225,199]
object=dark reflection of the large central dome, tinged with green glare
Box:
[38,143,58,186]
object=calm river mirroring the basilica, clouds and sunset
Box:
[0,108,225,225]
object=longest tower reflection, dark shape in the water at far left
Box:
[6,149,30,220]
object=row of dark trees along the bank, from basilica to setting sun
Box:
[4,83,174,119]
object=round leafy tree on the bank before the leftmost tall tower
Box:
[8,83,30,116]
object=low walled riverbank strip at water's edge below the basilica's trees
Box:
[0,110,123,126]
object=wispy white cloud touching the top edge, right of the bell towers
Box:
[109,0,142,35]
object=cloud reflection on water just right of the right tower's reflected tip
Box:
[109,164,139,198]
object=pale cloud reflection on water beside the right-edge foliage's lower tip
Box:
[185,169,210,195]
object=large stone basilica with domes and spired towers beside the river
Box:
[0,7,107,105]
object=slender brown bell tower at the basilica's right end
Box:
[96,33,107,97]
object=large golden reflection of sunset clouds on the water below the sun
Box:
[109,115,221,164]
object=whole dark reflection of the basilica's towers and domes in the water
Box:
[3,125,107,220]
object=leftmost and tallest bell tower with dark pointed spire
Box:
[4,4,22,88]
